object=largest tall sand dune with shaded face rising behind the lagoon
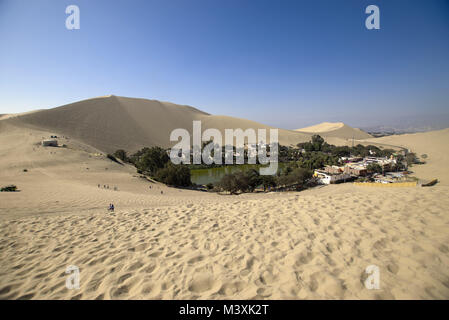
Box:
[2,95,310,152]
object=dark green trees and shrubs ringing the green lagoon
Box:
[111,135,419,194]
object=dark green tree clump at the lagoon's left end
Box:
[113,147,192,187]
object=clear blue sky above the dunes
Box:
[0,0,449,129]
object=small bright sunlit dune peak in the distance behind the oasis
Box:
[295,122,372,139]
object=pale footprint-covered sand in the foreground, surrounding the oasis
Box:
[0,108,449,299]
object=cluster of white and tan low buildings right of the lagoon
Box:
[314,156,407,184]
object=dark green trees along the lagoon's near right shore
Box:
[217,164,312,194]
